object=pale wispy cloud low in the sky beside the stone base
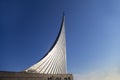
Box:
[74,68,120,80]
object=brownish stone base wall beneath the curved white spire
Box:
[0,71,73,80]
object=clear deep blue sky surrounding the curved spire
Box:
[0,0,120,74]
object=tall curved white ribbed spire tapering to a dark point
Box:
[25,14,66,74]
